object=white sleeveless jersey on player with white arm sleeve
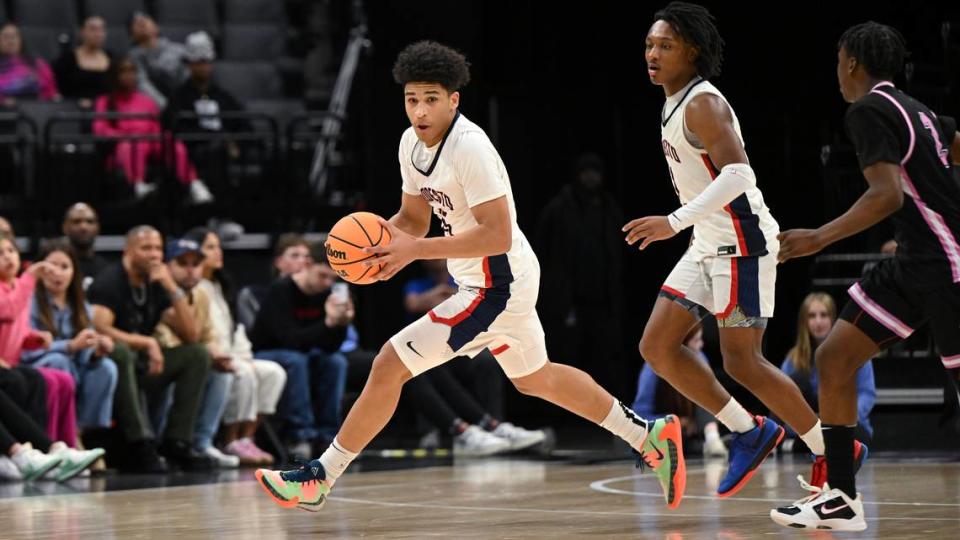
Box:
[660,79,780,256]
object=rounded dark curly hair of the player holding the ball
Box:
[393,41,470,92]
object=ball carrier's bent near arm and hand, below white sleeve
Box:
[363,195,513,281]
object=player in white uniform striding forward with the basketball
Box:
[256,41,686,511]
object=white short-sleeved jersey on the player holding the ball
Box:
[399,112,538,288]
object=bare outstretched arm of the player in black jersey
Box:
[777,161,903,262]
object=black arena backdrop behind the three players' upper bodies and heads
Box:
[354,0,958,404]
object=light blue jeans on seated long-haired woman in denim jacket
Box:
[30,349,118,429]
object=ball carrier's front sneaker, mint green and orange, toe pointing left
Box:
[254,459,330,512]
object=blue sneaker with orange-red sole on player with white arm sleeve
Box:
[717,416,785,497]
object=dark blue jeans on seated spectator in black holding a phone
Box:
[254,349,347,441]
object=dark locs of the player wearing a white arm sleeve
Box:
[653,2,723,79]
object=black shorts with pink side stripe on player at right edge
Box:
[840,258,960,369]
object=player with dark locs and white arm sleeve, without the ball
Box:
[624,2,864,497]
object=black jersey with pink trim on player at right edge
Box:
[845,82,960,288]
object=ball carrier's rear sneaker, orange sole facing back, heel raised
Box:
[637,414,687,510]
